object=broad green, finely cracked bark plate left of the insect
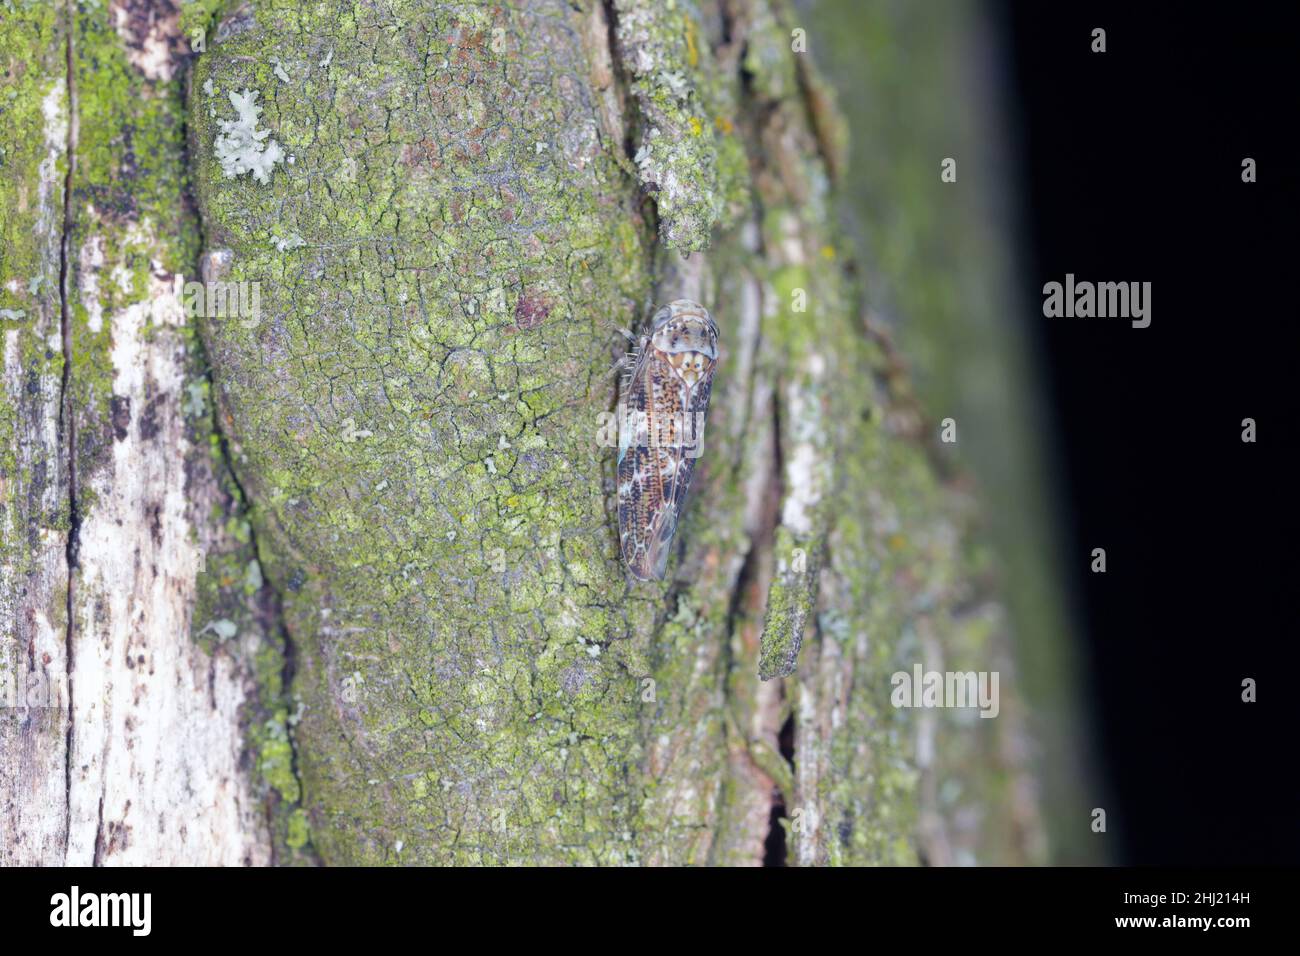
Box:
[191,4,653,862]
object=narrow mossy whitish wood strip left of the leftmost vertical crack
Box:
[0,13,70,865]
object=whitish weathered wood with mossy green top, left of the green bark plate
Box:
[0,3,269,865]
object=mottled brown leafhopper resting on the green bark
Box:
[619,299,718,580]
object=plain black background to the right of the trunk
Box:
[997,3,1300,864]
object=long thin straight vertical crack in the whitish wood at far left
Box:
[59,3,81,858]
